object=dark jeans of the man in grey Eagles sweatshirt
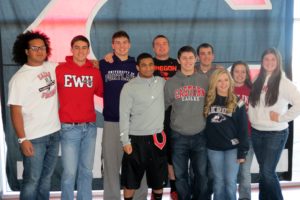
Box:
[171,130,208,200]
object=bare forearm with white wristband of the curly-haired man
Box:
[10,105,34,157]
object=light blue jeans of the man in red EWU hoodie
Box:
[61,123,97,200]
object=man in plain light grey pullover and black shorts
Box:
[120,53,168,200]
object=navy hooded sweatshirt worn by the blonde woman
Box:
[205,95,249,159]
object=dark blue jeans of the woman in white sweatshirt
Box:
[252,128,289,200]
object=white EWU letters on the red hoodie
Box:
[64,74,94,88]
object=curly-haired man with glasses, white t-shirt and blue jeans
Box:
[8,31,60,200]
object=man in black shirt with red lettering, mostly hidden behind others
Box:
[152,35,178,200]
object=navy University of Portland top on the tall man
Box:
[99,55,137,122]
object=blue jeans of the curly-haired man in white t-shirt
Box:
[20,132,60,200]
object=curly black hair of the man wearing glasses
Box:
[12,31,51,65]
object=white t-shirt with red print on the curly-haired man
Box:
[8,62,60,140]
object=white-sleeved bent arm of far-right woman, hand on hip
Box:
[270,77,300,122]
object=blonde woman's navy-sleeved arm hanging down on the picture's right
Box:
[236,100,249,163]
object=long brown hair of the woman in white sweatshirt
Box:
[249,48,282,107]
